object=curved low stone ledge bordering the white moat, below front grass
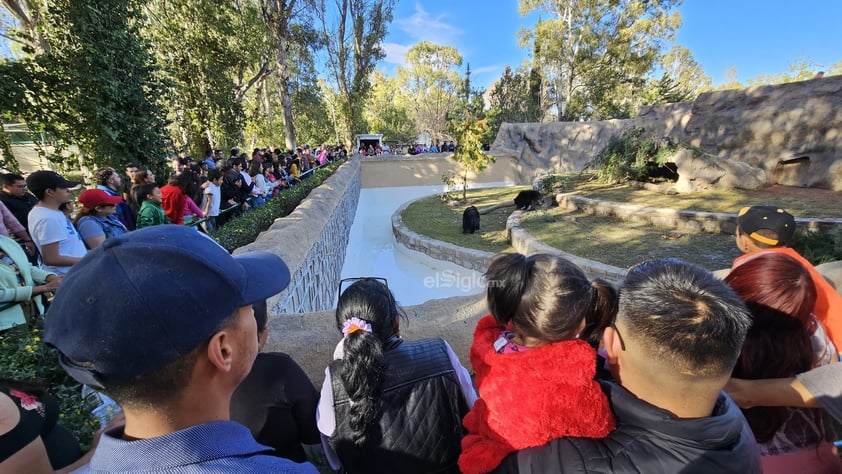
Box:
[392,198,495,272]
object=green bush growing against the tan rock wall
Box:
[596,128,678,183]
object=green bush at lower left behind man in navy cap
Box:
[0,319,99,448]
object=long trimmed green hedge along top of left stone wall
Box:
[209,162,343,252]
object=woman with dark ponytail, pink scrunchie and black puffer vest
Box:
[316,278,476,474]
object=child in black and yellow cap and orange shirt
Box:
[731,206,842,347]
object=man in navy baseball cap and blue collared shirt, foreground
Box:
[45,226,316,473]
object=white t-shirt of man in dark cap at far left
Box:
[29,206,88,275]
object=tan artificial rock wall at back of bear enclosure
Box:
[491,76,842,191]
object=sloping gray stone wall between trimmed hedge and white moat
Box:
[234,158,360,314]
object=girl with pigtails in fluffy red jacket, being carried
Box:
[459,253,617,474]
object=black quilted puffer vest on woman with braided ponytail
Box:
[330,338,468,474]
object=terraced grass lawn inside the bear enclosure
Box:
[403,173,842,270]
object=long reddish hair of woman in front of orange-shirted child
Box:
[725,252,816,443]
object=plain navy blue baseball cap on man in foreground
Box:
[44,225,290,388]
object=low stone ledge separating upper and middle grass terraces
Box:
[555,193,842,235]
